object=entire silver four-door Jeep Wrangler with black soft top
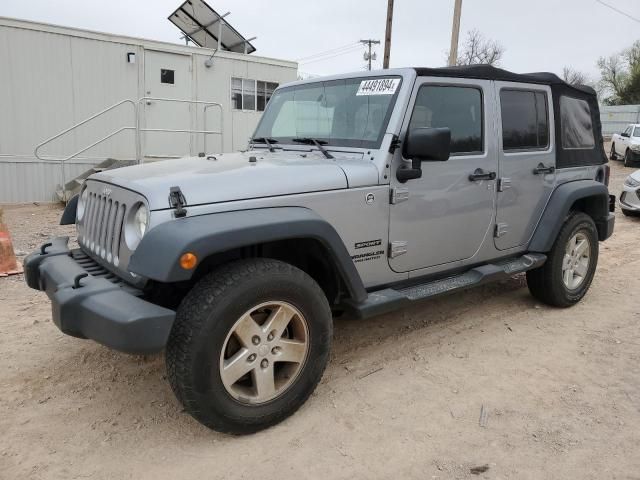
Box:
[25,66,615,434]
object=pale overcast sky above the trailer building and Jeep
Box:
[0,0,640,80]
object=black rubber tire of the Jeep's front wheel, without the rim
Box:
[166,258,333,434]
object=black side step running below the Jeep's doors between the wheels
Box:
[346,253,547,318]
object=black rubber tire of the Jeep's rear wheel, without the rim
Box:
[527,212,599,308]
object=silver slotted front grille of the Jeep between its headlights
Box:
[80,192,127,267]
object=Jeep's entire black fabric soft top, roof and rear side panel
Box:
[415,65,607,168]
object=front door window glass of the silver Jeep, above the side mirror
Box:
[409,85,484,155]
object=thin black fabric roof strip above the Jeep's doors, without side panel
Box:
[415,65,596,95]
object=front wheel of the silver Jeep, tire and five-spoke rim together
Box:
[166,259,332,434]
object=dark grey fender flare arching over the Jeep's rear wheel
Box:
[529,180,609,253]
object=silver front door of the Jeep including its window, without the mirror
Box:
[389,78,498,272]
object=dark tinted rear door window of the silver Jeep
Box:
[500,89,549,151]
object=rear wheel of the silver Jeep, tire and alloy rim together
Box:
[527,213,599,307]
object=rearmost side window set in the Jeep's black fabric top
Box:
[560,95,596,150]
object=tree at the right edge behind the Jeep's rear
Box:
[598,40,640,105]
